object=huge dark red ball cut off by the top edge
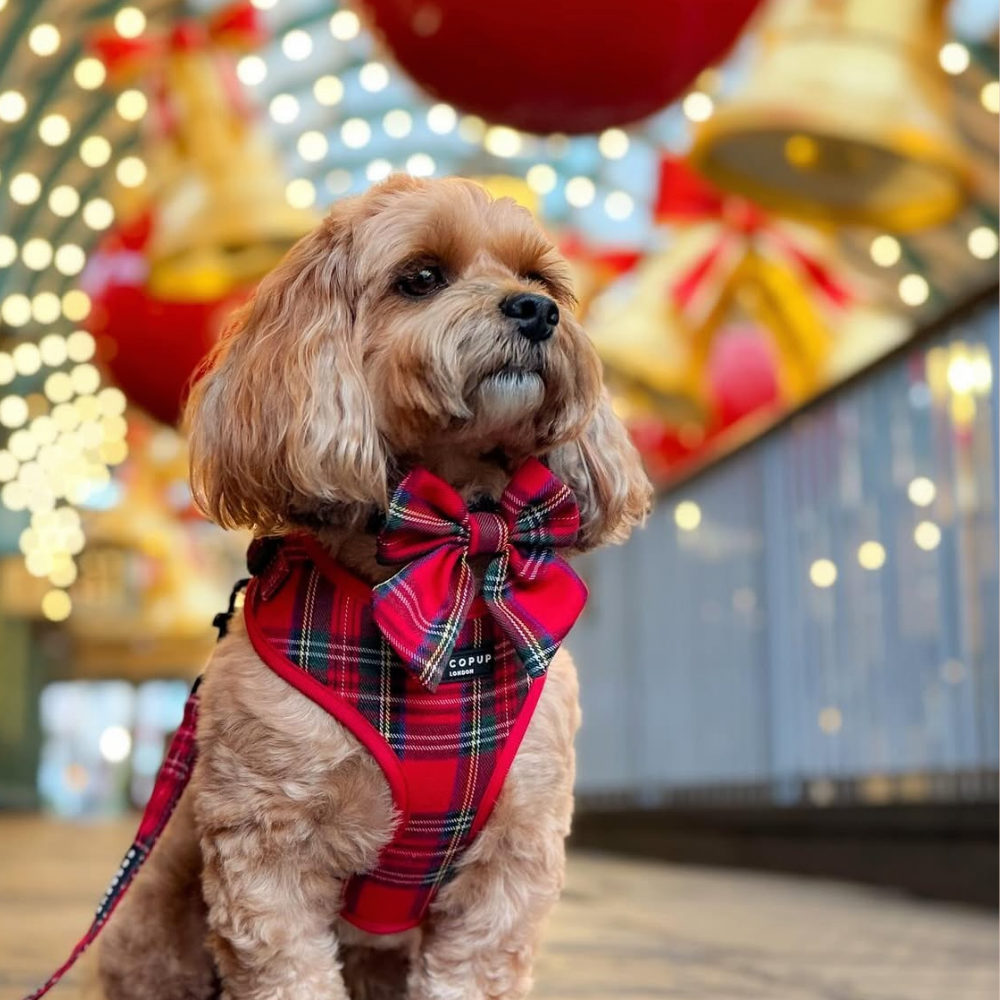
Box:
[360,0,760,134]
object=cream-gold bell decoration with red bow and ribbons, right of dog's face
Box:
[588,157,876,476]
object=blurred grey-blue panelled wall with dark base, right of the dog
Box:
[572,292,1000,905]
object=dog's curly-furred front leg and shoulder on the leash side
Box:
[191,626,393,1000]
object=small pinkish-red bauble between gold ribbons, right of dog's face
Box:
[708,326,781,427]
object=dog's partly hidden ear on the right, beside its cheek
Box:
[549,389,653,552]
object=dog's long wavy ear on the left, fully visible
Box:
[186,201,386,531]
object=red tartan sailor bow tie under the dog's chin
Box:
[372,459,587,691]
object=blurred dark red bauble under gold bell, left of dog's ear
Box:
[82,219,249,424]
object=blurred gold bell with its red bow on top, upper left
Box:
[94,0,317,301]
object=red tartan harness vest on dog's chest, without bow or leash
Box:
[244,537,556,933]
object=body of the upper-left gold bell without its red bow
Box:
[149,50,317,301]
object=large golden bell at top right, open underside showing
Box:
[691,0,967,232]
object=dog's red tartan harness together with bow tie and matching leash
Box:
[28,459,587,1000]
